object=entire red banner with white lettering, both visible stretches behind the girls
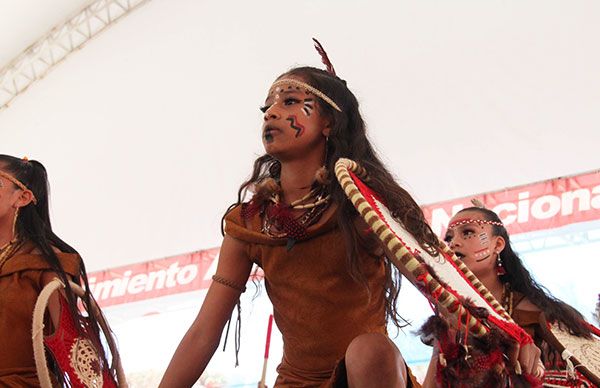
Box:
[89,171,600,307]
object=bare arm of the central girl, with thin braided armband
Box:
[160,236,252,388]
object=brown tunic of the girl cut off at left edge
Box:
[0,244,81,387]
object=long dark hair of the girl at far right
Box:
[458,207,591,338]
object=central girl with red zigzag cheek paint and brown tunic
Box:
[161,44,437,387]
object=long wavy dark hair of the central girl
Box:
[223,67,438,327]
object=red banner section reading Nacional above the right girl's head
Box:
[423,171,600,235]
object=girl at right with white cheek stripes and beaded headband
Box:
[426,207,592,386]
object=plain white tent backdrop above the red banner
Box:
[0,0,600,270]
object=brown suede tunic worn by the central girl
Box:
[225,206,386,387]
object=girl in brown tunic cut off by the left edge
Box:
[0,155,115,387]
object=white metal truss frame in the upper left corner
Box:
[0,0,150,111]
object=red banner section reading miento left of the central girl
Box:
[88,248,219,307]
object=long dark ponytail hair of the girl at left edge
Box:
[0,154,116,379]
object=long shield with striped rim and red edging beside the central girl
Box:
[335,159,532,345]
